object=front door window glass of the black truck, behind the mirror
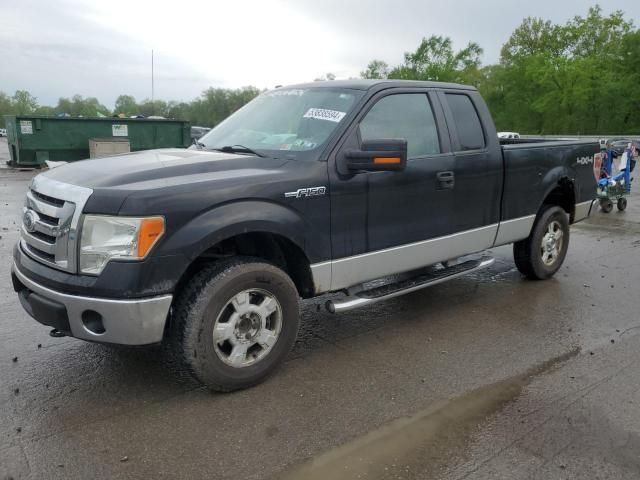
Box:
[360,93,440,158]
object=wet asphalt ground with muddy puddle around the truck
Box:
[0,140,640,480]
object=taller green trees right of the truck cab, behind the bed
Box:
[361,5,640,135]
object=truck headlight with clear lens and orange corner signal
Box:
[80,215,164,275]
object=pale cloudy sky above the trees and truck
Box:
[0,0,640,108]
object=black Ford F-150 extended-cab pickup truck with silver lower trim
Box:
[12,80,600,391]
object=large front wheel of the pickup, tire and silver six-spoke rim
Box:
[168,257,300,392]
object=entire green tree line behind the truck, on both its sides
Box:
[0,5,640,134]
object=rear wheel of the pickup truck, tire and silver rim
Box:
[513,205,569,280]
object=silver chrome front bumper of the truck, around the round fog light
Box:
[12,265,173,345]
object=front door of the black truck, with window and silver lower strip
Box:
[330,90,456,289]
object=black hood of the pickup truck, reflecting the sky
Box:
[43,149,287,191]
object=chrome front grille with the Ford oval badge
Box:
[21,174,93,272]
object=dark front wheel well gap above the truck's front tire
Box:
[176,232,315,298]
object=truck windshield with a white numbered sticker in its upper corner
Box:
[198,87,364,160]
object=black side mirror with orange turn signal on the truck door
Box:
[345,138,407,172]
